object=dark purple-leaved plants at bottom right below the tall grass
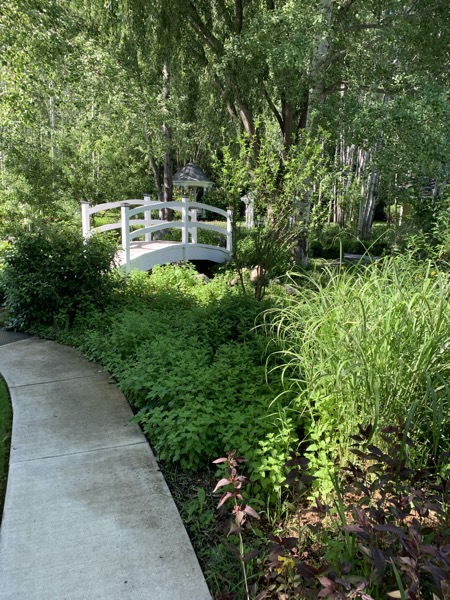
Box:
[258,420,450,600]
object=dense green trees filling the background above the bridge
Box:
[0,0,450,244]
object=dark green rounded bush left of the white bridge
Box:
[2,226,116,330]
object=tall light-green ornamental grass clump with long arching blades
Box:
[270,257,450,478]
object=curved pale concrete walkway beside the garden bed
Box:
[0,331,210,600]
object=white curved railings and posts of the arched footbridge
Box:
[81,195,232,266]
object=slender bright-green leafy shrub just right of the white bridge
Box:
[216,131,327,300]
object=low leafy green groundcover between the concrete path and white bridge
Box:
[66,264,295,498]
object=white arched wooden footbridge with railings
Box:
[81,196,232,273]
